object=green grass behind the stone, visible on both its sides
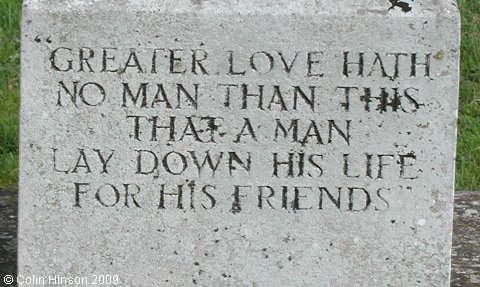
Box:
[0,0,480,190]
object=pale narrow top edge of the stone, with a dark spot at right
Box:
[23,0,459,17]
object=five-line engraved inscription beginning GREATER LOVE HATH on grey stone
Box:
[45,43,435,214]
